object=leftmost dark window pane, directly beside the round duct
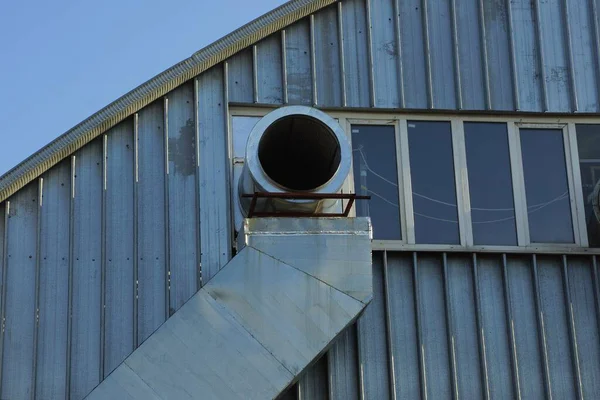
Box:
[352,125,402,240]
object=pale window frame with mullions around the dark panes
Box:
[229,105,600,254]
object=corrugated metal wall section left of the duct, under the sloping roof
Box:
[0,66,231,399]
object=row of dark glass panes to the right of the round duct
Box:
[352,121,600,246]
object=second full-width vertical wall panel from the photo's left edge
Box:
[35,159,71,399]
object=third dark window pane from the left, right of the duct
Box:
[464,122,517,245]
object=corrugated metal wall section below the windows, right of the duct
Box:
[288,253,600,400]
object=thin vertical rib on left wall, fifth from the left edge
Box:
[133,113,140,349]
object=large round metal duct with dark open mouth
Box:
[239,106,351,214]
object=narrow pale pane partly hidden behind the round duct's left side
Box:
[231,117,260,230]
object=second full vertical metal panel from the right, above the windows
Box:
[538,0,571,111]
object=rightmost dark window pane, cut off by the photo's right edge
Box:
[577,125,600,247]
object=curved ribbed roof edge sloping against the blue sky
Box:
[0,0,337,202]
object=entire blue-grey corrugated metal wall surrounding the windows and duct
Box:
[0,0,600,399]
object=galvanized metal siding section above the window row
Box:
[228,0,600,112]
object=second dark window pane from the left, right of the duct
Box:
[408,121,460,244]
